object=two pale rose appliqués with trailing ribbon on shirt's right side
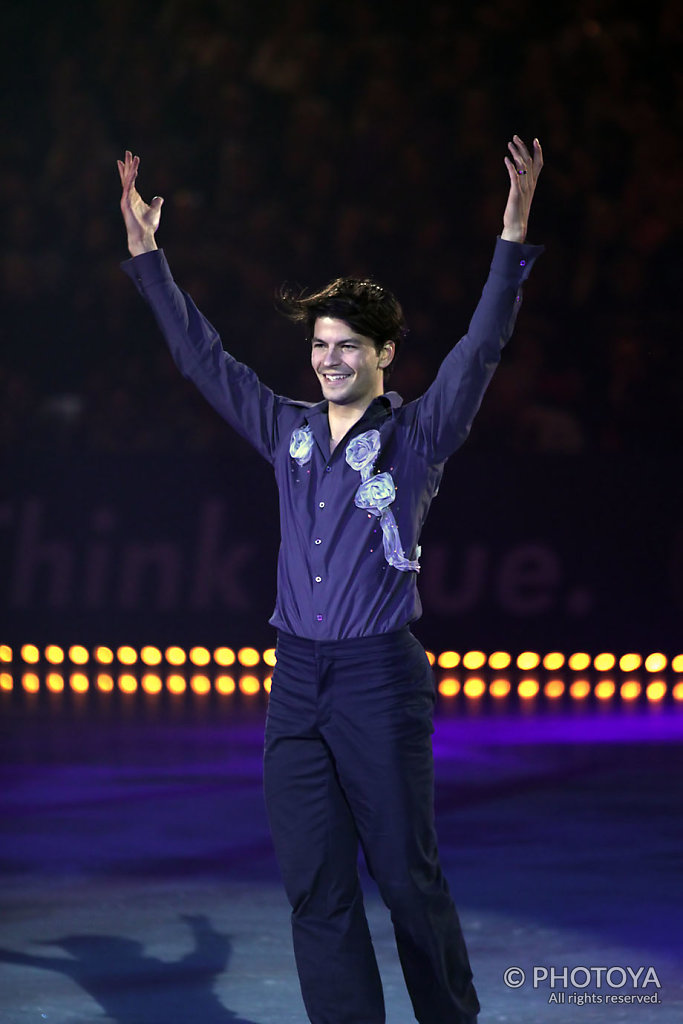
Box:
[345,430,420,572]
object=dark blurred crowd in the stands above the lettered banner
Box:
[0,0,683,455]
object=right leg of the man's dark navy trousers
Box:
[324,634,479,1024]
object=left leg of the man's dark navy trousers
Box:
[264,648,384,1024]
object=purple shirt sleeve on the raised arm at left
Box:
[121,249,280,463]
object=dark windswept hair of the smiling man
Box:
[278,278,408,377]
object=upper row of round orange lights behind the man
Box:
[0,644,683,674]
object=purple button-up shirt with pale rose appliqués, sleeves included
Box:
[122,239,543,640]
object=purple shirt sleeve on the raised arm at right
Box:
[411,238,544,463]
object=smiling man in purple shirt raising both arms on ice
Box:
[119,135,543,1024]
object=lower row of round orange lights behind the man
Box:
[0,672,683,702]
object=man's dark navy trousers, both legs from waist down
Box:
[264,629,479,1024]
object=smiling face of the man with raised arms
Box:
[310,316,395,411]
